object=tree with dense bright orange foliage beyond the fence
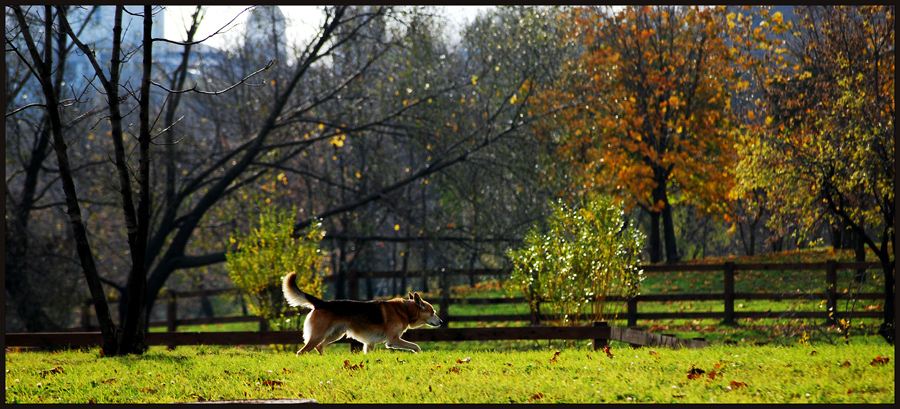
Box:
[537,6,734,262]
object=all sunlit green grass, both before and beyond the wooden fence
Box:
[6,250,895,403]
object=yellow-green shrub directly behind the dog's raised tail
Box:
[225,203,325,330]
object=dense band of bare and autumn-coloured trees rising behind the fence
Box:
[5,6,895,346]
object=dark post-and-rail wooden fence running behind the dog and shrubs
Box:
[72,261,884,332]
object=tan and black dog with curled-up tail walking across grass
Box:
[281,273,441,355]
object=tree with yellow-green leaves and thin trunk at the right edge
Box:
[727,6,896,343]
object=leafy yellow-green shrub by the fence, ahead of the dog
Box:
[508,196,644,325]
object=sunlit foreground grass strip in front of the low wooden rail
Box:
[6,341,895,403]
